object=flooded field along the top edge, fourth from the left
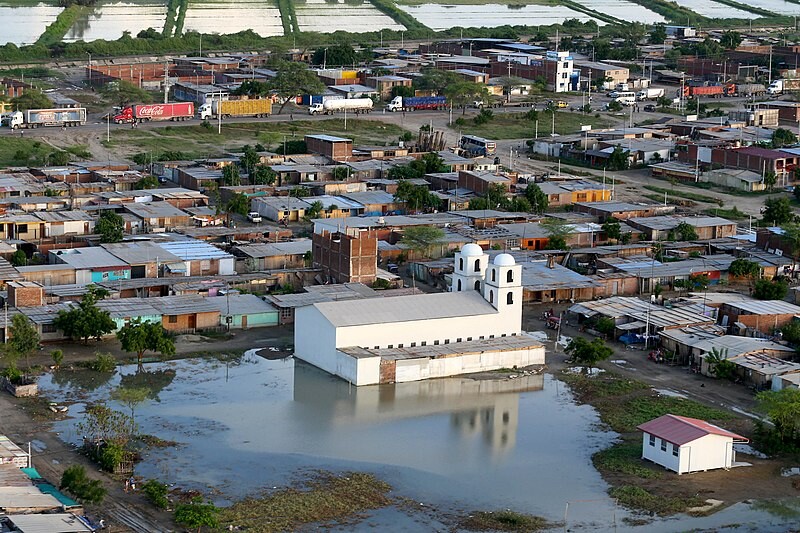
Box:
[295,0,405,33]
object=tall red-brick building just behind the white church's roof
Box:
[311,228,378,285]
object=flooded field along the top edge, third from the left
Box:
[183,0,283,37]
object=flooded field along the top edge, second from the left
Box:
[64,0,167,42]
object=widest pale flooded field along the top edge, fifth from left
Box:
[397,4,605,30]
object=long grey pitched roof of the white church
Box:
[314,291,498,327]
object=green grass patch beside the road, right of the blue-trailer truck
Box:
[450,111,611,140]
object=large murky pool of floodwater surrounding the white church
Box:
[39,351,800,531]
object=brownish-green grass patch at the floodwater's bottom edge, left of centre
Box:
[219,472,391,533]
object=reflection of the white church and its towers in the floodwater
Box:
[294,360,544,455]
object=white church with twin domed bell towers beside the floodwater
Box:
[295,244,544,385]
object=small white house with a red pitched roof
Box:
[637,415,748,474]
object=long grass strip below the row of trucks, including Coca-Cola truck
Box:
[109,119,404,158]
